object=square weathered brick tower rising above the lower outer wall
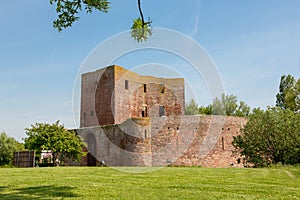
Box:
[80,65,185,127]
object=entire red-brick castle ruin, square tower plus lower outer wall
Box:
[75,65,246,167]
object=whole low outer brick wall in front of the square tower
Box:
[77,115,247,167]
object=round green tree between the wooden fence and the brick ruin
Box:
[25,121,83,165]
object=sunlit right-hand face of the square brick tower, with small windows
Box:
[114,66,184,123]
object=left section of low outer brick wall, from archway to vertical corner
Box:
[75,118,151,166]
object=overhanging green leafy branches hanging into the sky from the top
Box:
[50,0,152,42]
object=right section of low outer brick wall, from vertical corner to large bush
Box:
[151,115,247,167]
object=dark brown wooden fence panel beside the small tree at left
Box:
[13,151,35,167]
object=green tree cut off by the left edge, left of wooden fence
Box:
[0,132,18,165]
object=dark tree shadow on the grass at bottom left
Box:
[0,186,79,200]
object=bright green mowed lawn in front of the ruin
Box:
[0,167,300,200]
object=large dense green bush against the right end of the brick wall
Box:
[233,107,300,167]
